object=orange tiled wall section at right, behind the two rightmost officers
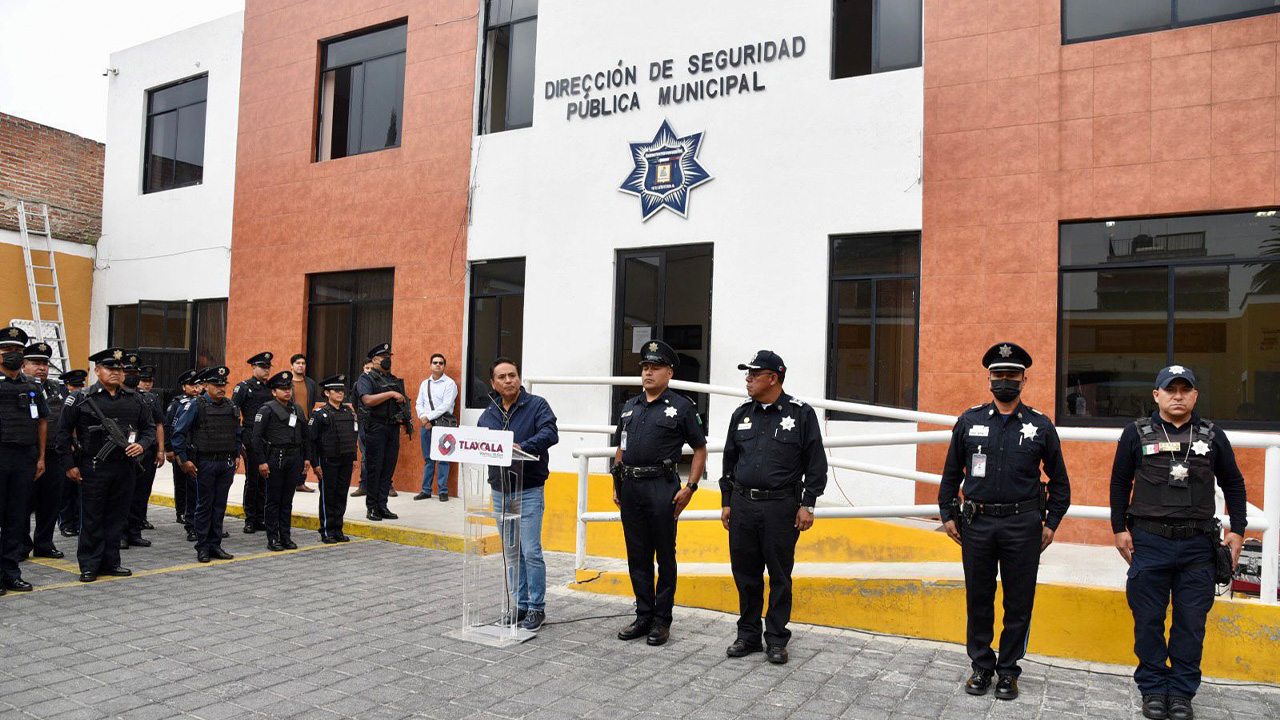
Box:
[919,0,1280,542]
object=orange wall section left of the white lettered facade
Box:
[227,0,477,489]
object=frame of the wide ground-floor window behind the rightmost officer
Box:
[1053,209,1280,432]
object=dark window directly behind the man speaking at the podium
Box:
[466,258,525,407]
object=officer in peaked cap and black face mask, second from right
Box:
[938,342,1071,700]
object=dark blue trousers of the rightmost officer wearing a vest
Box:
[1125,528,1215,698]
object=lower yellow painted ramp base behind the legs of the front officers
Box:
[570,570,1280,683]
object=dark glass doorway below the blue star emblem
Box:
[612,245,712,420]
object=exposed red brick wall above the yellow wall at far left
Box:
[0,113,105,245]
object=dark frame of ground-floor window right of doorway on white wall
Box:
[826,229,924,423]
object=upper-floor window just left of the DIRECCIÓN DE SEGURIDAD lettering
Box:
[480,0,538,133]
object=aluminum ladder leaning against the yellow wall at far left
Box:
[18,200,69,375]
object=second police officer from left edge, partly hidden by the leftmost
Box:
[22,342,70,559]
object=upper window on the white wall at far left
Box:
[142,76,209,192]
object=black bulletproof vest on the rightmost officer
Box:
[1129,418,1215,520]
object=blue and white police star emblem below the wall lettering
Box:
[618,120,712,220]
